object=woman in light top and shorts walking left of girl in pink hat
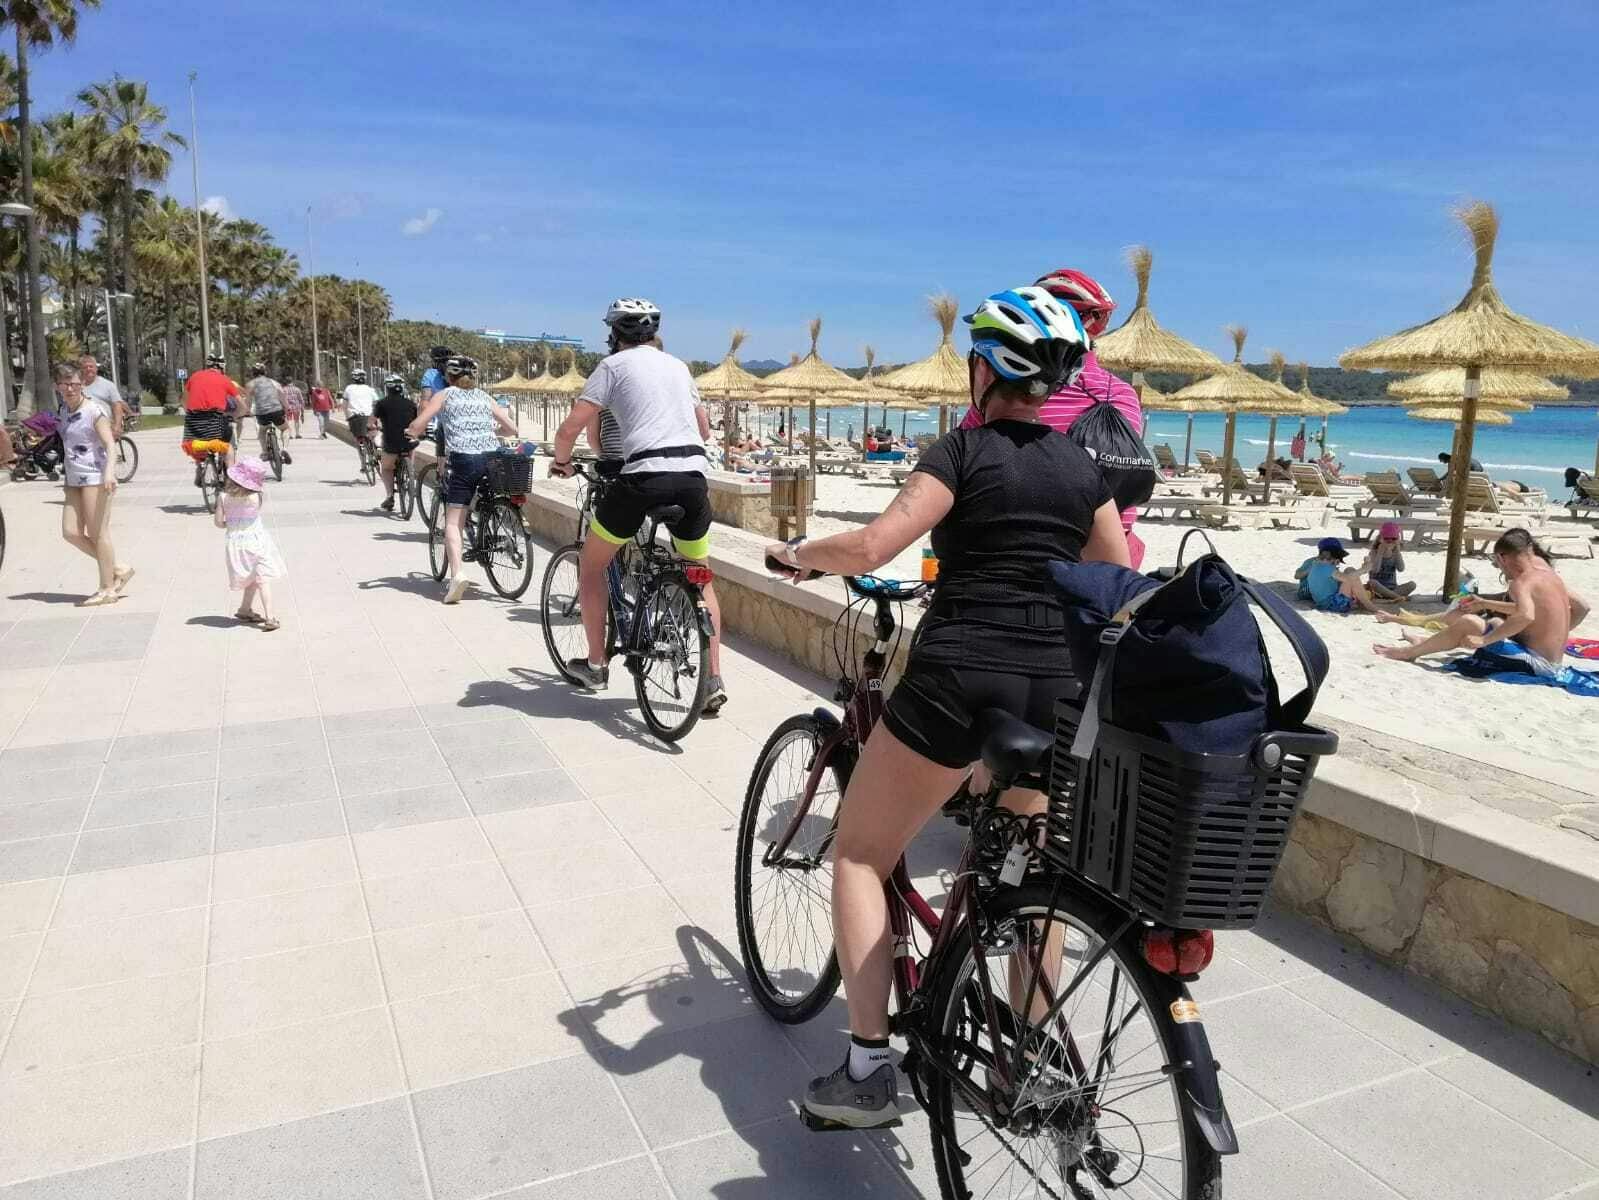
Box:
[56,363,133,608]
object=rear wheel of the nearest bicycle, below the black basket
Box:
[919,878,1222,1200]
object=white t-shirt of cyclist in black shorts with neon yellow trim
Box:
[580,346,710,475]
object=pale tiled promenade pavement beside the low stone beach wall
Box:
[0,430,1599,1200]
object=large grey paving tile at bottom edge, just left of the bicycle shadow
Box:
[416,1056,649,1200]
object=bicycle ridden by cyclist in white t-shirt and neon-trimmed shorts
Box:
[539,466,712,741]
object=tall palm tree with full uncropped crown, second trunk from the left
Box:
[78,75,189,390]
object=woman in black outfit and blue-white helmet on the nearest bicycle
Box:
[768,288,1127,1128]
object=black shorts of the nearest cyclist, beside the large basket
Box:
[883,654,1078,768]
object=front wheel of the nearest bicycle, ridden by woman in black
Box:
[732,714,854,1026]
